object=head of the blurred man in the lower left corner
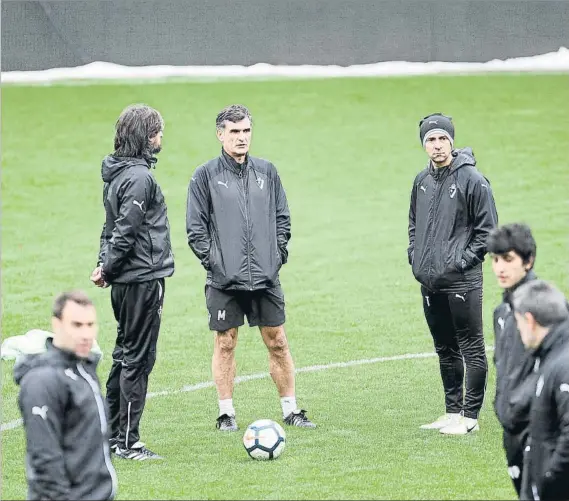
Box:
[52,301,98,358]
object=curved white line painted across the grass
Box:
[0,346,494,431]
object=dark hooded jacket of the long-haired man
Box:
[99,155,174,284]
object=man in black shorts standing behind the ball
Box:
[186,105,316,431]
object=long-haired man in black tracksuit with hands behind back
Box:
[91,105,174,461]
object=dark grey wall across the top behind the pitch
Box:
[1,0,569,71]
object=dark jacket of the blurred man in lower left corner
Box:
[14,343,117,500]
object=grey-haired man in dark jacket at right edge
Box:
[513,280,569,500]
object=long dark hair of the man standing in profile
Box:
[114,104,164,161]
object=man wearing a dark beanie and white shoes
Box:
[408,113,498,435]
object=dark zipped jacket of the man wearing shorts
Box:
[186,148,291,290]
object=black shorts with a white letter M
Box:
[205,285,285,332]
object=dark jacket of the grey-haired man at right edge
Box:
[521,321,569,500]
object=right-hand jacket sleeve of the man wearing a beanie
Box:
[462,177,498,270]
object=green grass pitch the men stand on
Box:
[2,75,569,499]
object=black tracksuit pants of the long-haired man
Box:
[107,278,164,448]
